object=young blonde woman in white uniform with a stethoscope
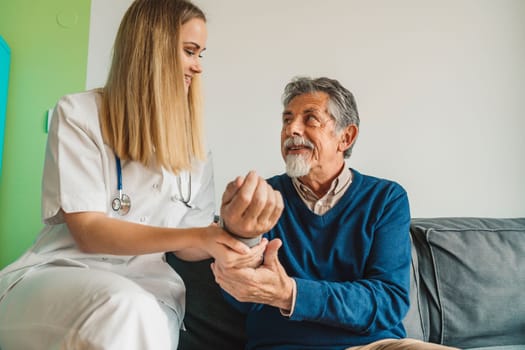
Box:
[0,0,282,350]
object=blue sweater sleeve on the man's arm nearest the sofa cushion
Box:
[290,184,410,334]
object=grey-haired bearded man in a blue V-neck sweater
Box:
[212,78,456,350]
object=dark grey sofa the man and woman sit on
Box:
[167,218,525,350]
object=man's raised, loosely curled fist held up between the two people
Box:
[221,171,284,238]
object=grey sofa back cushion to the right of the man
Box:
[411,218,525,348]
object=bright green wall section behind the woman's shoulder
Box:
[0,0,91,269]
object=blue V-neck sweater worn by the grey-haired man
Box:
[229,169,410,349]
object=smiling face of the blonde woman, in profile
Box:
[180,18,208,93]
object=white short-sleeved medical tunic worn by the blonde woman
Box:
[0,91,215,323]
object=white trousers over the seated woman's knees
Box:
[0,267,180,350]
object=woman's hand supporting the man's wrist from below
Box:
[202,224,268,268]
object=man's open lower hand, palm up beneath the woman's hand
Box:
[211,239,295,310]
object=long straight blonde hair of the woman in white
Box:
[100,0,206,174]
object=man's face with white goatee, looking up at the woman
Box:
[281,92,346,177]
